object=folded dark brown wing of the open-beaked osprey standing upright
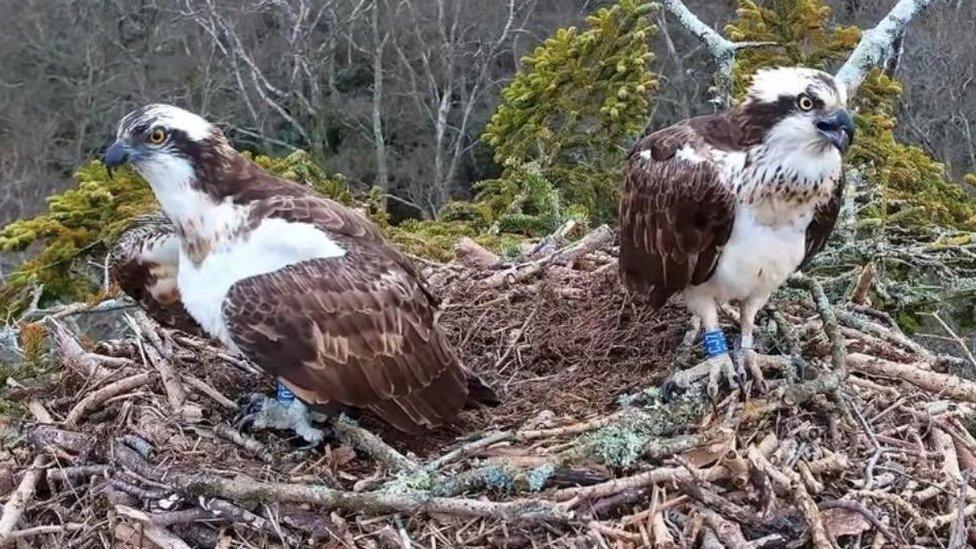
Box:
[620,117,735,306]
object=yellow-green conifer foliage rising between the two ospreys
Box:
[481,0,656,225]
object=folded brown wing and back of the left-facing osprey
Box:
[223,196,494,432]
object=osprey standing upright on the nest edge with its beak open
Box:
[619,68,854,395]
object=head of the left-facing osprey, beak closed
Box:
[103,104,224,184]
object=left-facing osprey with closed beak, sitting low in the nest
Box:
[104,105,494,444]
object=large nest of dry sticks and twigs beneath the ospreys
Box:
[0,228,976,548]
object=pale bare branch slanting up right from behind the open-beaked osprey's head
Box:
[837,0,933,95]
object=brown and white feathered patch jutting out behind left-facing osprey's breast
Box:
[108,213,204,336]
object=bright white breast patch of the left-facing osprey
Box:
[179,218,346,348]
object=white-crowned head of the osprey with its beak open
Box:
[742,67,854,154]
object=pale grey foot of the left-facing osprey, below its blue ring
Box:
[234,393,328,448]
